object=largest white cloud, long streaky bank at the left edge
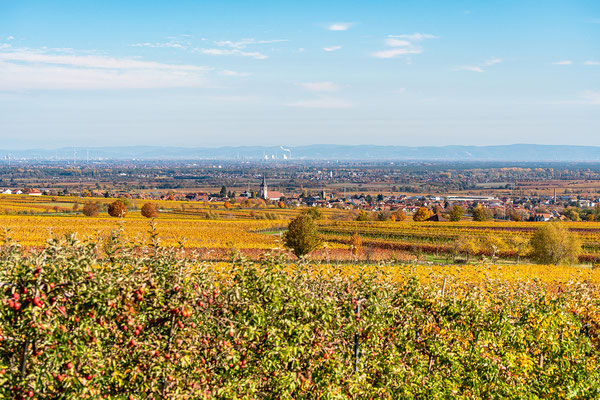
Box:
[0,49,209,90]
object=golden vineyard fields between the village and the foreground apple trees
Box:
[0,195,600,265]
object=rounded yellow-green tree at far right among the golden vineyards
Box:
[529,223,581,265]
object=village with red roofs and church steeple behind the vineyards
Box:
[0,175,600,222]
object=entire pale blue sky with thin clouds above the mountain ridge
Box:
[0,0,600,148]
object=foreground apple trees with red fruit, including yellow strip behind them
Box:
[0,230,600,399]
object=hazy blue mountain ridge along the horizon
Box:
[0,144,600,162]
